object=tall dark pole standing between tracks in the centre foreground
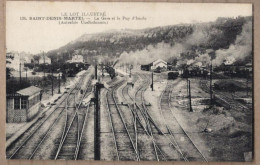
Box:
[92,82,104,160]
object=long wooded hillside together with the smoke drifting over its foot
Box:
[44,17,252,65]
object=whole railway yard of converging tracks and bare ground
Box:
[6,67,253,162]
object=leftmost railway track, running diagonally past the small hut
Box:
[6,71,89,159]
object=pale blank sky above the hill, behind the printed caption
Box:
[6,1,252,54]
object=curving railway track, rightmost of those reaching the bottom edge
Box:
[160,80,207,162]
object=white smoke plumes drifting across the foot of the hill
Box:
[119,21,252,67]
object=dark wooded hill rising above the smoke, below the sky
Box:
[42,17,252,65]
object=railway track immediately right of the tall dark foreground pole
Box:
[106,80,140,161]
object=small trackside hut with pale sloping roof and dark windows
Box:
[6,86,42,123]
